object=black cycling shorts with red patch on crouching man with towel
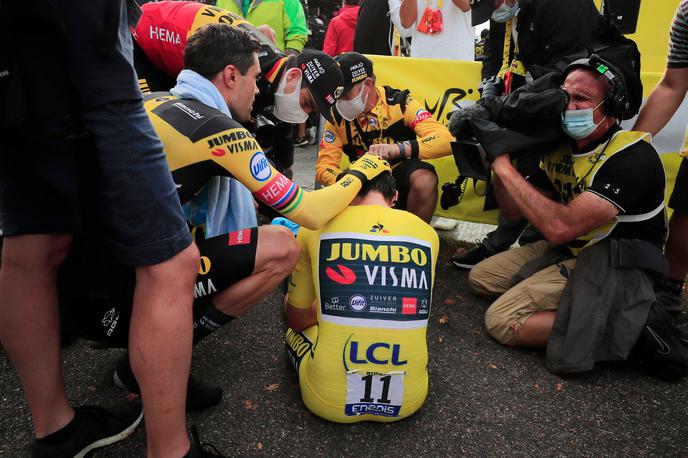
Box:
[58,227,258,348]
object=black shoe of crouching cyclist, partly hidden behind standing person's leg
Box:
[112,355,222,412]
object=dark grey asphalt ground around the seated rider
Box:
[0,243,688,458]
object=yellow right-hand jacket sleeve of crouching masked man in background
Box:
[404,96,453,159]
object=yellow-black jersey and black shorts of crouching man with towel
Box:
[58,93,389,346]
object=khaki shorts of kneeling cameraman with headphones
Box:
[468,241,576,344]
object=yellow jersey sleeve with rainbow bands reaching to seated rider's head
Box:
[195,123,370,229]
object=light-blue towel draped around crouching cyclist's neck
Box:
[170,70,258,238]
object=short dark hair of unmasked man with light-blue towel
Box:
[184,24,261,79]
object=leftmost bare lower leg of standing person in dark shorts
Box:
[0,234,74,438]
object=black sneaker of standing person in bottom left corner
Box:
[31,402,143,458]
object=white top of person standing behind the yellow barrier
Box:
[408,0,475,61]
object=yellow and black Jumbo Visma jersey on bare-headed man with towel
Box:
[144,92,388,228]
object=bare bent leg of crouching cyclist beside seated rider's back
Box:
[212,226,299,317]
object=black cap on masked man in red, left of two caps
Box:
[296,49,344,121]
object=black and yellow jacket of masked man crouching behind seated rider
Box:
[315,86,453,185]
